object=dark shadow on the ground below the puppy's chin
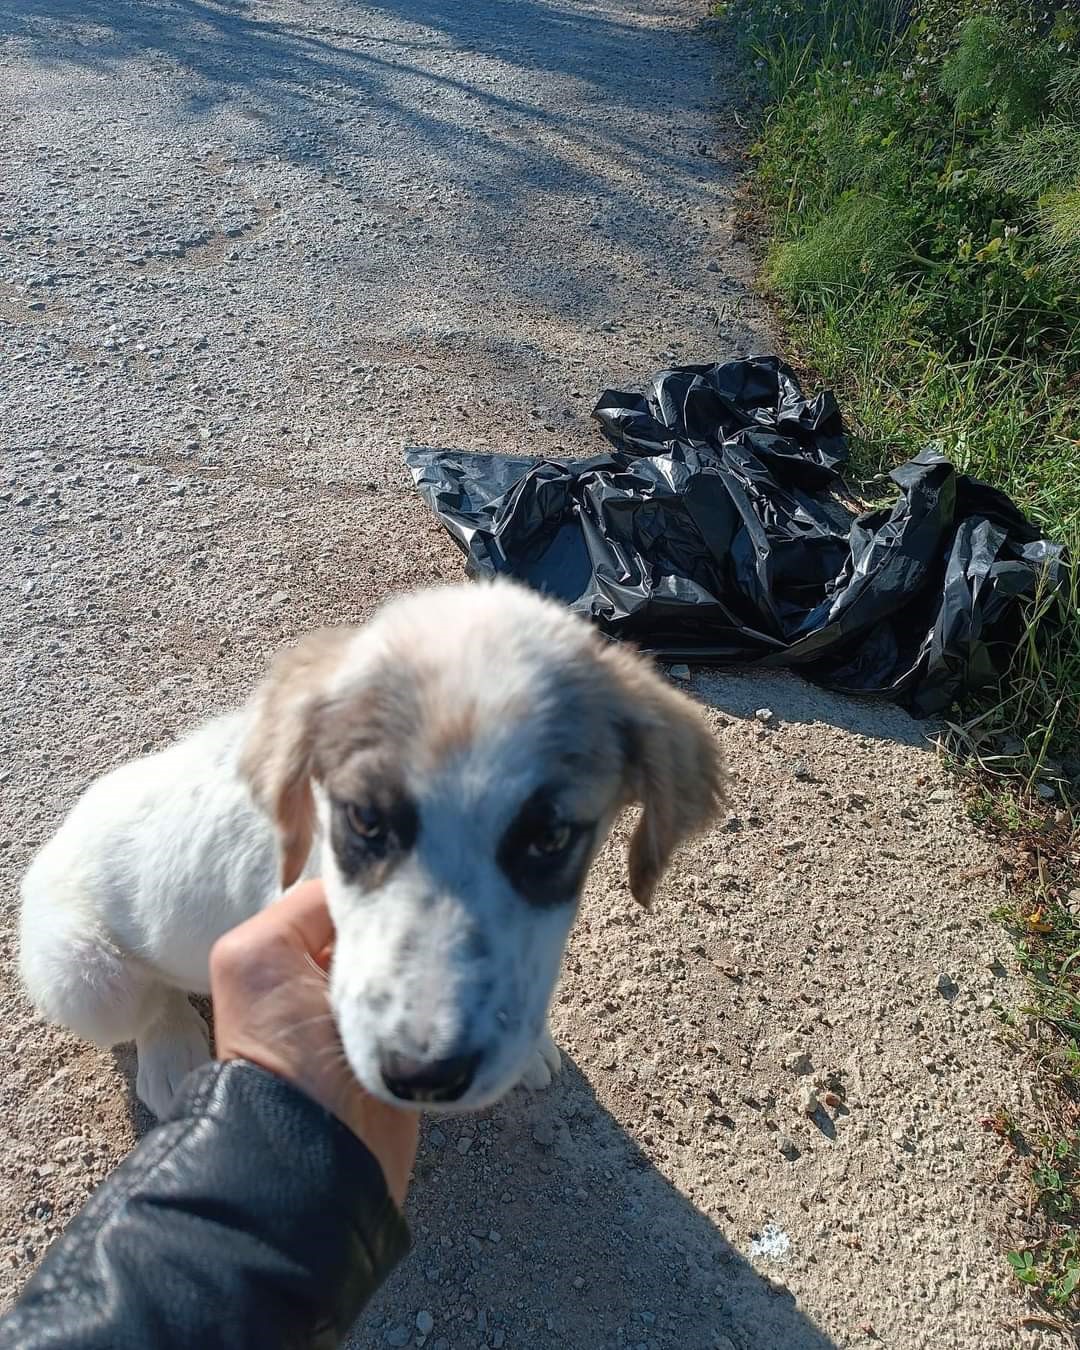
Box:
[350,1060,834,1350]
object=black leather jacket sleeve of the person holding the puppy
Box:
[0,1061,409,1350]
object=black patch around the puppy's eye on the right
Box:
[495,788,595,906]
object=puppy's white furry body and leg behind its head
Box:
[20,710,307,1115]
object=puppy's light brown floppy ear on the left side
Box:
[240,628,355,890]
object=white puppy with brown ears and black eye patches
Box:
[20,582,724,1115]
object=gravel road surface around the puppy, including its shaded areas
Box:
[0,0,1057,1350]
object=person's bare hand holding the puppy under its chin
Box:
[211,882,419,1207]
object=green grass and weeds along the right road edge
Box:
[718,0,1080,1324]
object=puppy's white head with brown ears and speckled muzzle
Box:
[244,582,722,1110]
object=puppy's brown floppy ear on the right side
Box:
[602,645,725,909]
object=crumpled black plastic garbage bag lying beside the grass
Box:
[406,356,1061,716]
